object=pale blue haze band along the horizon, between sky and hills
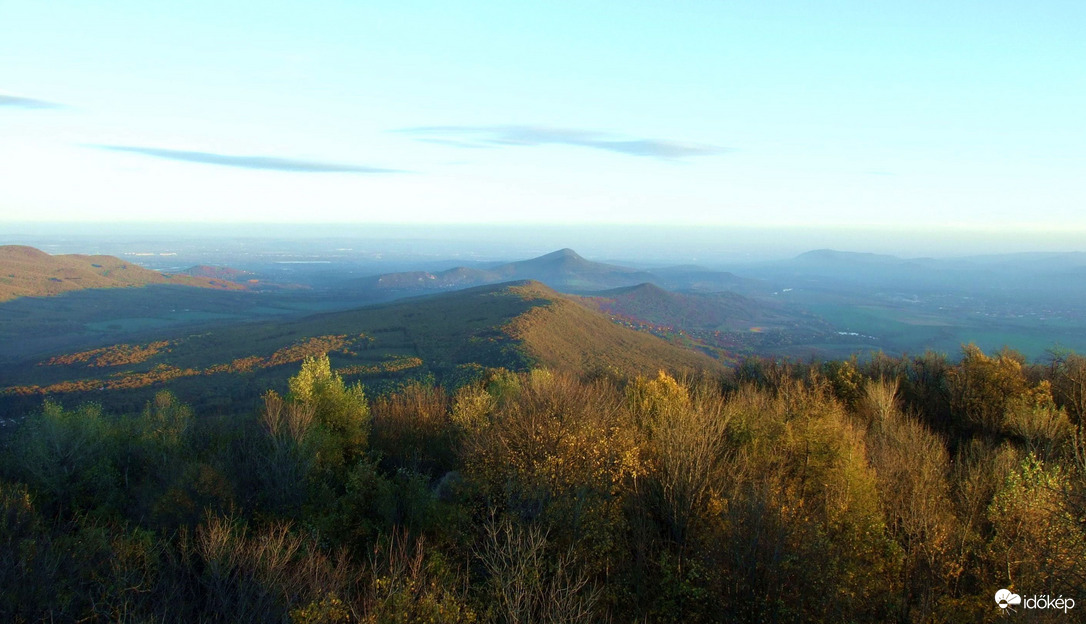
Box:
[0,222,1086,266]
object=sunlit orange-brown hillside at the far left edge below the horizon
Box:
[0,245,243,302]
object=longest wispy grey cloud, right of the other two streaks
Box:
[400,126,730,158]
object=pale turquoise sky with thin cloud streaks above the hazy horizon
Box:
[0,0,1086,235]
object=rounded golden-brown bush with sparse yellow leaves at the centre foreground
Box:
[454,372,644,568]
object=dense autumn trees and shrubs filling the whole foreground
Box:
[0,346,1086,623]
